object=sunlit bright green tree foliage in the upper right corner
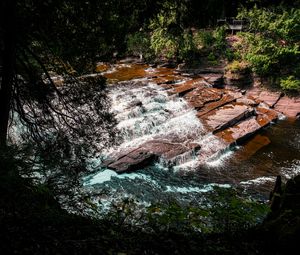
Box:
[237,7,300,84]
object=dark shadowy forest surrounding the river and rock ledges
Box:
[0,0,300,254]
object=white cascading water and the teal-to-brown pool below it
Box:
[83,63,300,213]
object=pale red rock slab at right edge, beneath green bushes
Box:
[274,96,300,118]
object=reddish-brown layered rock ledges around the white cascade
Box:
[98,60,300,173]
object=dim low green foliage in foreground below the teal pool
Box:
[103,188,268,235]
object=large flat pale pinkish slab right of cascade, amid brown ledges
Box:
[201,104,254,133]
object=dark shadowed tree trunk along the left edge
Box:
[0,0,16,147]
